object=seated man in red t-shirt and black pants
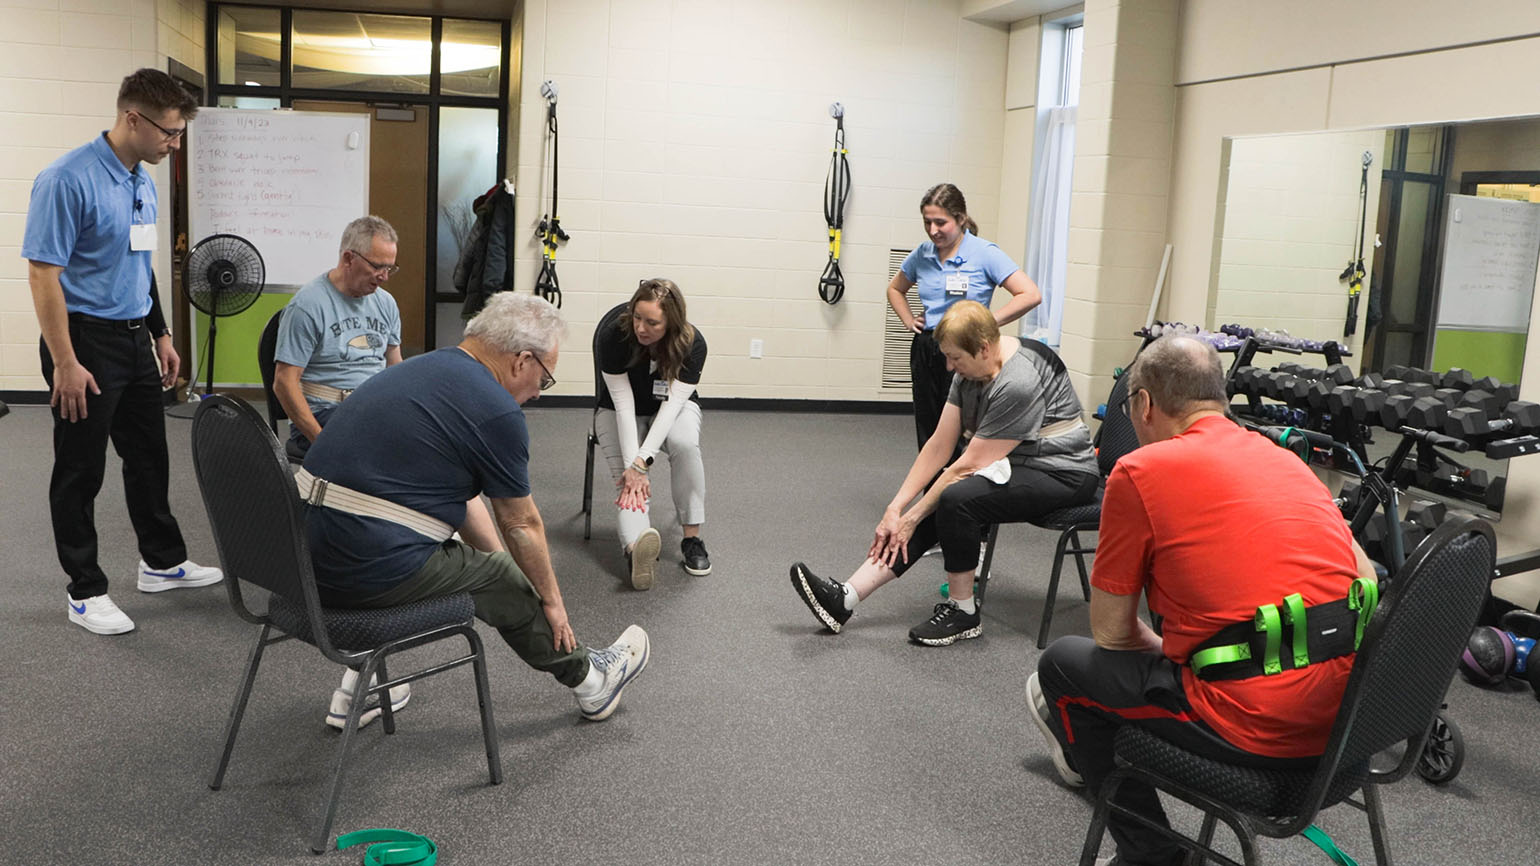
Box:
[1027,336,1374,866]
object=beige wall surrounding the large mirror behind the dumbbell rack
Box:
[1158,0,1540,606]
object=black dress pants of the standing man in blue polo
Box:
[39,316,188,599]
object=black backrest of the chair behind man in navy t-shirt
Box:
[193,394,325,625]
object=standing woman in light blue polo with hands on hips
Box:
[887,183,1043,448]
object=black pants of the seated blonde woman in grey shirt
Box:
[893,465,1101,575]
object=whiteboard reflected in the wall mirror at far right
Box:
[1437,196,1540,331]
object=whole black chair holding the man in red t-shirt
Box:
[1080,516,1497,866]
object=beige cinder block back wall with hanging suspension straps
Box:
[516,0,1009,401]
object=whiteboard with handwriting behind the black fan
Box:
[188,108,370,288]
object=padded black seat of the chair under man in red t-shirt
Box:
[1113,726,1369,818]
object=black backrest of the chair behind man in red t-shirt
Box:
[1317,515,1497,790]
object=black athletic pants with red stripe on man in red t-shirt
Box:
[1038,635,1315,866]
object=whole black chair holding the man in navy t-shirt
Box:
[193,394,502,854]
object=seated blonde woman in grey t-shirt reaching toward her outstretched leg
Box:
[792,300,1100,646]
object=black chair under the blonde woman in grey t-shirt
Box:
[978,366,1140,649]
